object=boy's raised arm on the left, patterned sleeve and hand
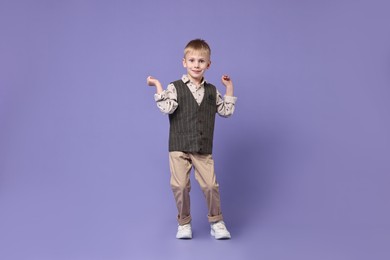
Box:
[146,76,178,114]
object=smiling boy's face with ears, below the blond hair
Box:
[183,50,211,83]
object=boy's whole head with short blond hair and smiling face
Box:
[183,39,211,84]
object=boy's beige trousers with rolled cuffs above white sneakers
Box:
[169,152,223,225]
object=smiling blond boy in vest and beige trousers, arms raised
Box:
[147,39,237,239]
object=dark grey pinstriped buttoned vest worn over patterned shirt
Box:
[169,80,217,154]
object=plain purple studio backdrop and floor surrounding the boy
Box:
[0,0,390,260]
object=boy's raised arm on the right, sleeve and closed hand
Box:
[217,75,237,117]
